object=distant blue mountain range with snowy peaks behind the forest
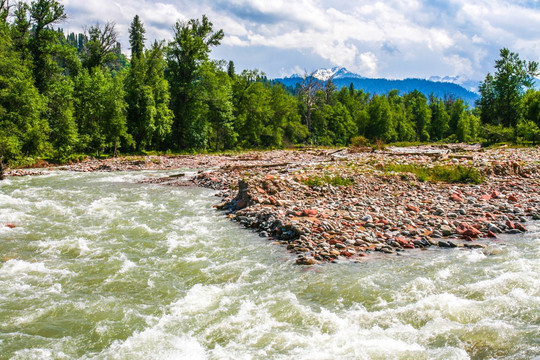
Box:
[274,67,479,107]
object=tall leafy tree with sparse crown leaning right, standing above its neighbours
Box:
[167,15,224,149]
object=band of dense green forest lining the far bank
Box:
[0,0,540,166]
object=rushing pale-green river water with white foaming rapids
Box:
[0,172,540,360]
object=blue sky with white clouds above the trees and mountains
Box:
[59,0,540,81]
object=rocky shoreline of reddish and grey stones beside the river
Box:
[6,145,540,265]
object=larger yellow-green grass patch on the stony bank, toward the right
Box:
[384,164,484,184]
